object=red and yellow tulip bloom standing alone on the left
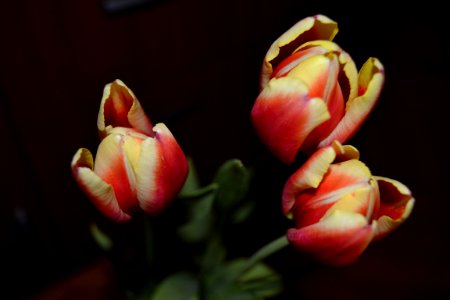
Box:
[71,80,188,222]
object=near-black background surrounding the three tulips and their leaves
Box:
[0,0,450,299]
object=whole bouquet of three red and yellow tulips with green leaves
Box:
[71,15,414,300]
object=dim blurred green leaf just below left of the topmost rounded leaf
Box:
[178,192,214,243]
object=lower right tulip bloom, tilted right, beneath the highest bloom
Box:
[283,142,414,266]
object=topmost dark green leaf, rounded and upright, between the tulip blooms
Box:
[213,159,251,211]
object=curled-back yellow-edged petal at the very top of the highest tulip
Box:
[260,15,338,90]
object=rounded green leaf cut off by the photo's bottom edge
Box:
[150,272,200,300]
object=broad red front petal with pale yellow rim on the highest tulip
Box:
[251,77,330,163]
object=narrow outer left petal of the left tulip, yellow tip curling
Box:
[71,148,131,222]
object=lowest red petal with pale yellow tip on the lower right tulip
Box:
[287,210,373,266]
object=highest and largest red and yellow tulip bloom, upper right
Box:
[251,15,384,163]
